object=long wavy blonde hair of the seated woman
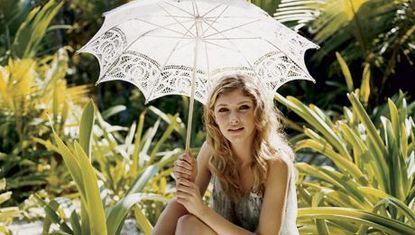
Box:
[204,74,294,201]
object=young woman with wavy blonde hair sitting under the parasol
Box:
[153,75,298,235]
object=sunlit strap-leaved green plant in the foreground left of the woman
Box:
[38,102,186,234]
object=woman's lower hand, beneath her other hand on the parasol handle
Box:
[176,178,205,217]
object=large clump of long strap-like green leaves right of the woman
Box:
[276,54,415,234]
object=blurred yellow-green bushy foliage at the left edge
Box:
[0,49,88,203]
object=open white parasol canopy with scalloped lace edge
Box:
[80,0,318,149]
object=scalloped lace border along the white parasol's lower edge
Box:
[82,27,314,103]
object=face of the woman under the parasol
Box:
[214,90,255,144]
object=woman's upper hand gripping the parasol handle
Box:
[173,153,197,183]
